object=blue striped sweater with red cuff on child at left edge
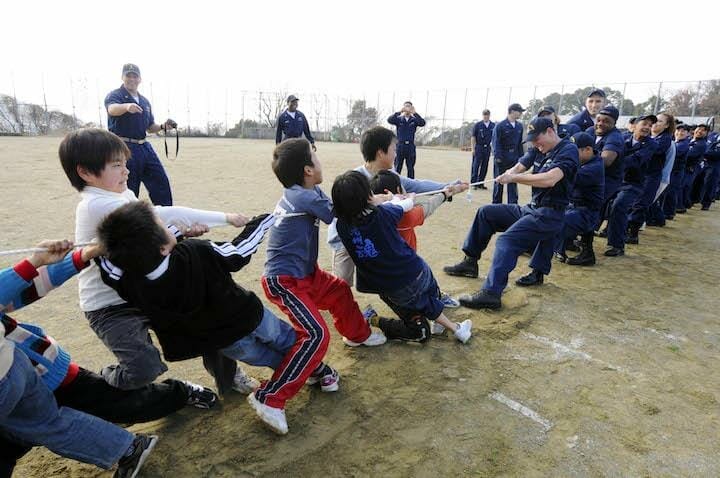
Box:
[0,250,87,390]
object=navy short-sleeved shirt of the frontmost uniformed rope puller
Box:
[521,139,580,207]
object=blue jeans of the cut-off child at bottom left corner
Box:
[0,346,134,469]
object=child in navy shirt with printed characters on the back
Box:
[332,171,472,343]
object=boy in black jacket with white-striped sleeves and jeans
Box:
[98,202,296,433]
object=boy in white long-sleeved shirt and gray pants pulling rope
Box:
[58,128,258,393]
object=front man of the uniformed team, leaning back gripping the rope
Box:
[443,118,579,309]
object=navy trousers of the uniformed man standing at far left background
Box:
[125,143,172,206]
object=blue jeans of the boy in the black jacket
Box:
[222,307,295,370]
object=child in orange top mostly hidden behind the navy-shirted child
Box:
[370,170,467,312]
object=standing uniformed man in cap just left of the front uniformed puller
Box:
[492,103,525,204]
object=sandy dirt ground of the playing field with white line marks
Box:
[0,138,720,477]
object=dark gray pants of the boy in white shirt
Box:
[85,304,167,390]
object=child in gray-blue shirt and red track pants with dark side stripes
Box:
[256,138,386,431]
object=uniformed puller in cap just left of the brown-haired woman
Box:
[605,115,657,257]
